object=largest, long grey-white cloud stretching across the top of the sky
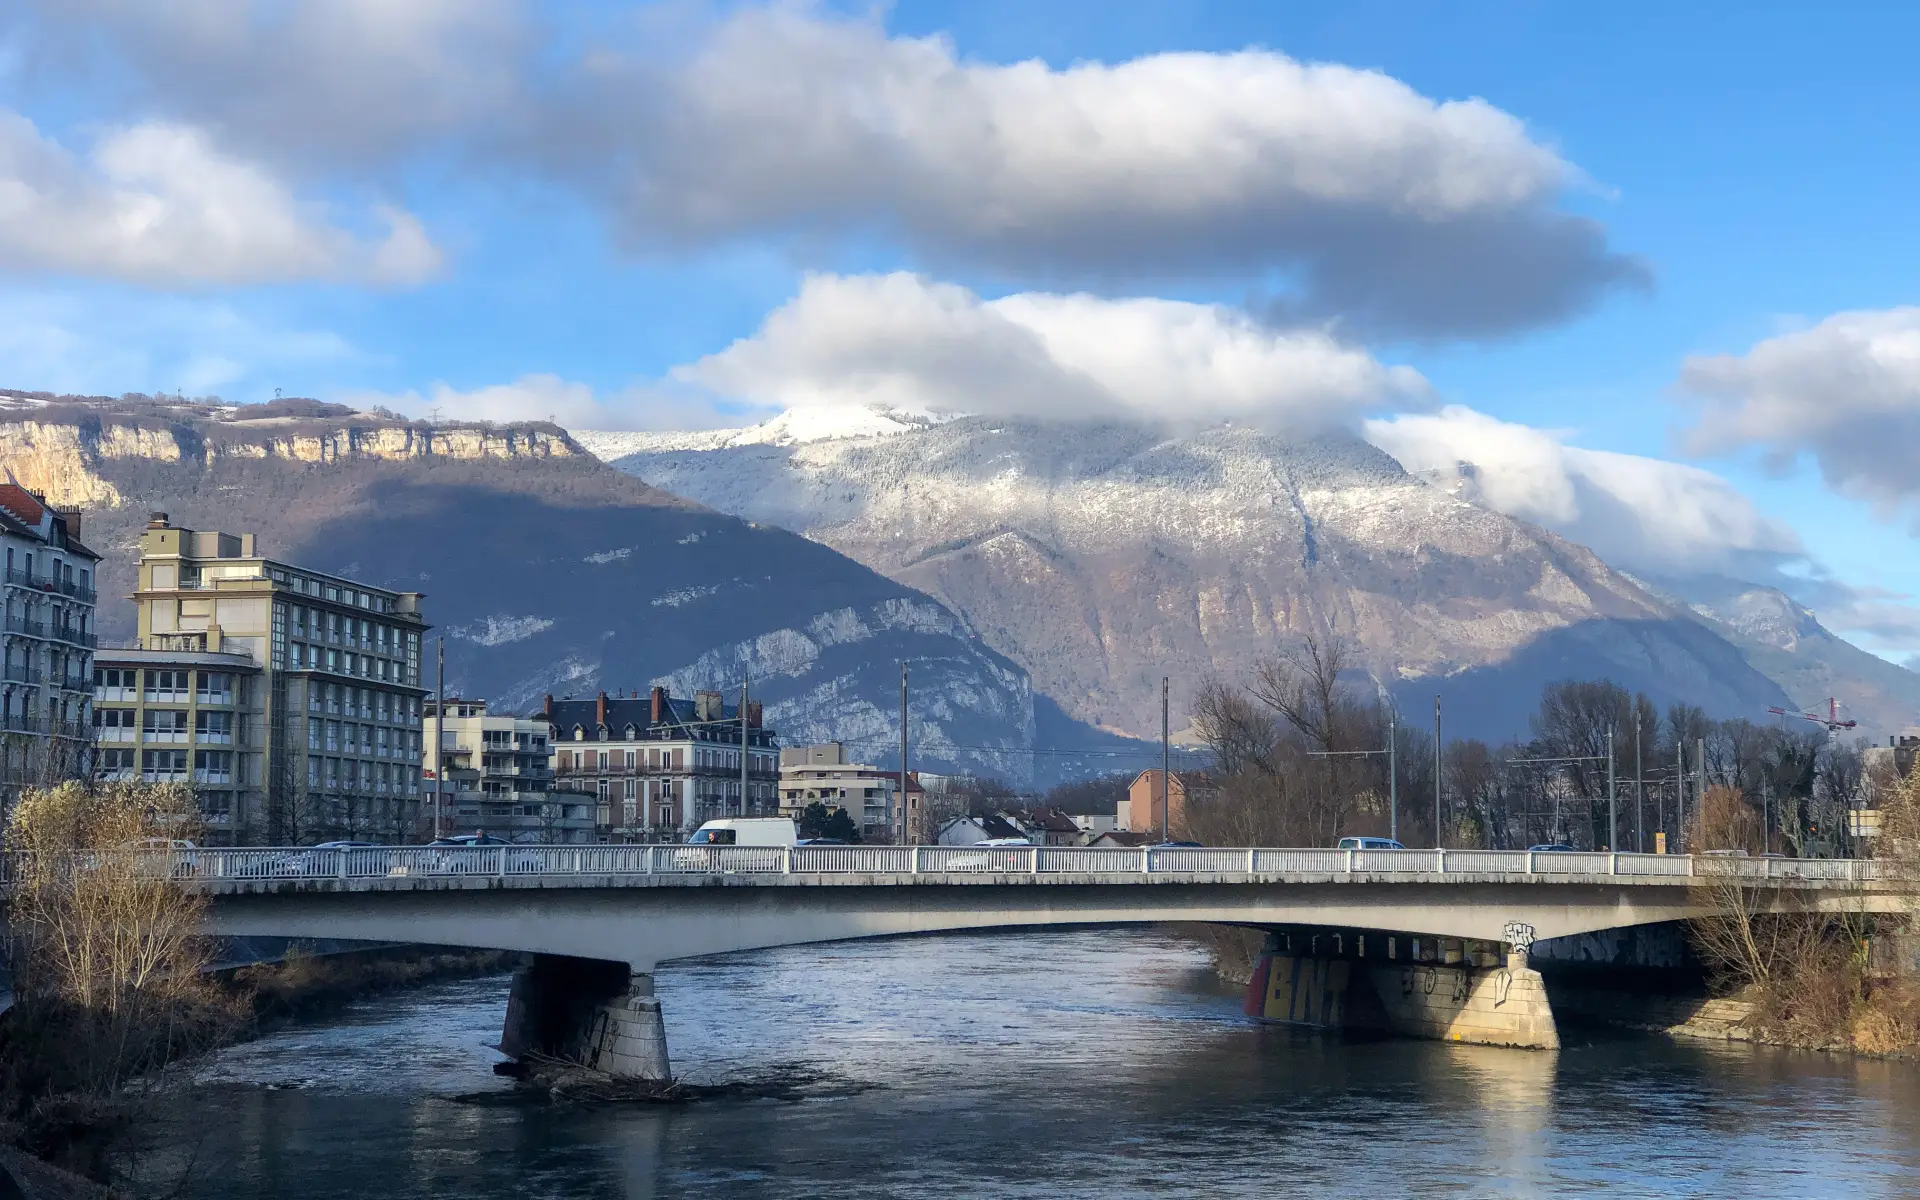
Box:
[18,0,1649,338]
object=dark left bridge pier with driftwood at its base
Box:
[499,954,674,1083]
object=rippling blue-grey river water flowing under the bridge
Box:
[145,929,1920,1200]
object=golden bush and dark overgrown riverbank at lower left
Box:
[0,781,511,1183]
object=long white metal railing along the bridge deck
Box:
[108,845,1887,883]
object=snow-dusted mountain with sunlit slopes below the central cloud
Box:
[574,411,1786,737]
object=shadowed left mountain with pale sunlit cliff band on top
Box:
[0,394,1067,781]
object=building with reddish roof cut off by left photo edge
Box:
[0,484,100,791]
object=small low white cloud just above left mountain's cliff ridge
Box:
[357,374,770,430]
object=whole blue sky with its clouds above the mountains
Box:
[0,0,1920,660]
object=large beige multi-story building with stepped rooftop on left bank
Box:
[94,513,428,843]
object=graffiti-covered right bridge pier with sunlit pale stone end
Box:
[1246,927,1559,1050]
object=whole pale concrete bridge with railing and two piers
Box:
[171,845,1912,1079]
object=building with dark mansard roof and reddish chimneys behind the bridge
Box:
[541,687,780,841]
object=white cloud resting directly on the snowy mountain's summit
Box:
[674,273,1427,432]
